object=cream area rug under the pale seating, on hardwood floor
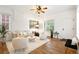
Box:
[6,39,49,54]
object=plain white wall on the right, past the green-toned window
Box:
[53,9,76,39]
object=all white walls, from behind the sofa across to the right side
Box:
[12,6,76,39]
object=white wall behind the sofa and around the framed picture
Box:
[12,6,44,31]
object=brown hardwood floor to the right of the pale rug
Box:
[30,39,76,54]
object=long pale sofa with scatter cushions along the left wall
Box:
[5,31,27,41]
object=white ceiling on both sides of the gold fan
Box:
[0,5,76,13]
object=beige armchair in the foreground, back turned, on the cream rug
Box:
[12,39,27,53]
